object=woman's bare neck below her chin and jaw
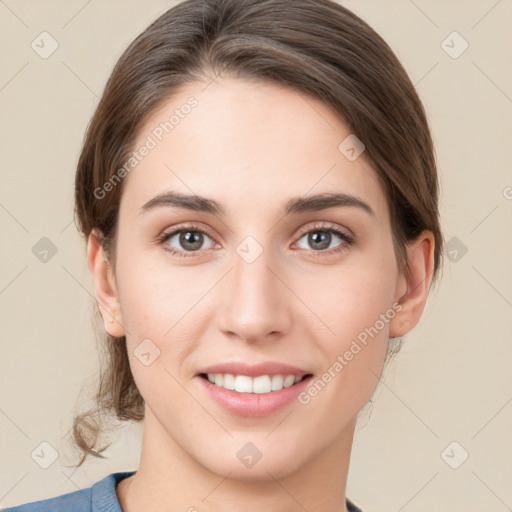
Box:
[116,405,356,512]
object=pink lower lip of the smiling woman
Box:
[197,375,312,416]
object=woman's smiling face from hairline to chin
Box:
[95,79,416,479]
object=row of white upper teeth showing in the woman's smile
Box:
[207,373,303,394]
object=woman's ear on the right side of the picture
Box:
[389,231,435,338]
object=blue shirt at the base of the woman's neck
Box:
[2,471,362,512]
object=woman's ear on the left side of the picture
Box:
[87,229,125,337]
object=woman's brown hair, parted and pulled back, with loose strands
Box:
[72,0,443,466]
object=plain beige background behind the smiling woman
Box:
[0,0,512,512]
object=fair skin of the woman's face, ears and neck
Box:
[88,78,434,512]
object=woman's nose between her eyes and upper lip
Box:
[217,244,293,343]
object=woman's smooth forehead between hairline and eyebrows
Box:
[117,79,387,224]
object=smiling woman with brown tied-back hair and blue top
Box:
[4,0,442,512]
